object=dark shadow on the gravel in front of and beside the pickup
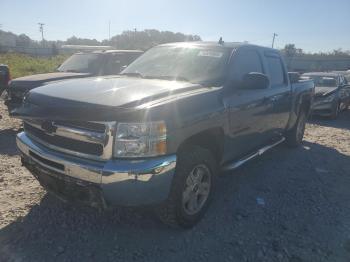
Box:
[0,142,350,261]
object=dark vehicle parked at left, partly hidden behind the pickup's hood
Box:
[5,50,143,115]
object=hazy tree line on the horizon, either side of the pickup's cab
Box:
[0,29,350,64]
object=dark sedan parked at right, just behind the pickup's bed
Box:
[302,72,350,119]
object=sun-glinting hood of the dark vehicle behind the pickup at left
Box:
[10,72,90,91]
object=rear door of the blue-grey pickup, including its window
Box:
[264,50,292,135]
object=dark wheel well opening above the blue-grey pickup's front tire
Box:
[179,128,224,163]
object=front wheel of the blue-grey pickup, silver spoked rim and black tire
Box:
[156,146,217,228]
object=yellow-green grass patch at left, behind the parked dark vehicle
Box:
[0,53,69,79]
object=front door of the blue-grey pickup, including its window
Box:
[223,48,278,161]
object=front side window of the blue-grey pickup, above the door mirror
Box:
[230,50,263,82]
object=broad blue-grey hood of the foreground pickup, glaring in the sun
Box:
[13,77,207,121]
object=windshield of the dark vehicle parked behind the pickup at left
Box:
[57,54,101,73]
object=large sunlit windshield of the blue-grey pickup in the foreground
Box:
[122,46,230,86]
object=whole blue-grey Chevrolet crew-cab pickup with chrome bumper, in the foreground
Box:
[15,42,314,227]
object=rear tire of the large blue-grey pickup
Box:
[286,110,307,147]
